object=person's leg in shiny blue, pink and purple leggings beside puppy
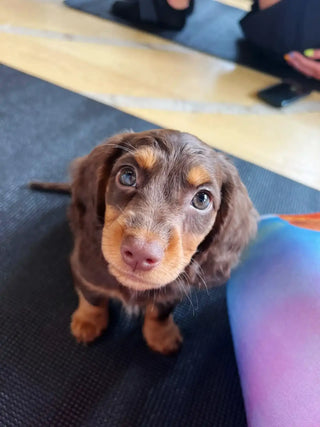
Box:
[227,213,320,427]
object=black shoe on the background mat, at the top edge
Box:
[111,0,194,30]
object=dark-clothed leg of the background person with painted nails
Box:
[240,0,320,56]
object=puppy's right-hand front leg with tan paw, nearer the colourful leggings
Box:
[142,304,182,354]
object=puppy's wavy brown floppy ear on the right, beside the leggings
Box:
[194,153,258,285]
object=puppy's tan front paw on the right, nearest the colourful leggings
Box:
[143,316,183,355]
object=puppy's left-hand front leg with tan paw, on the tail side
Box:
[71,290,108,343]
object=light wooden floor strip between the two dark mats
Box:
[0,0,320,191]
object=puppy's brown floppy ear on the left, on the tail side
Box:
[70,134,128,228]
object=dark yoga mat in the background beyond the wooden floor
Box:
[65,0,320,90]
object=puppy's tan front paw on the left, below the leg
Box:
[71,309,108,344]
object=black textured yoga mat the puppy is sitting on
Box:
[0,66,320,427]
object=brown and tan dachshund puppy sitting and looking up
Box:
[34,130,257,354]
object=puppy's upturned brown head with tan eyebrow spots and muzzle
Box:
[84,130,252,290]
